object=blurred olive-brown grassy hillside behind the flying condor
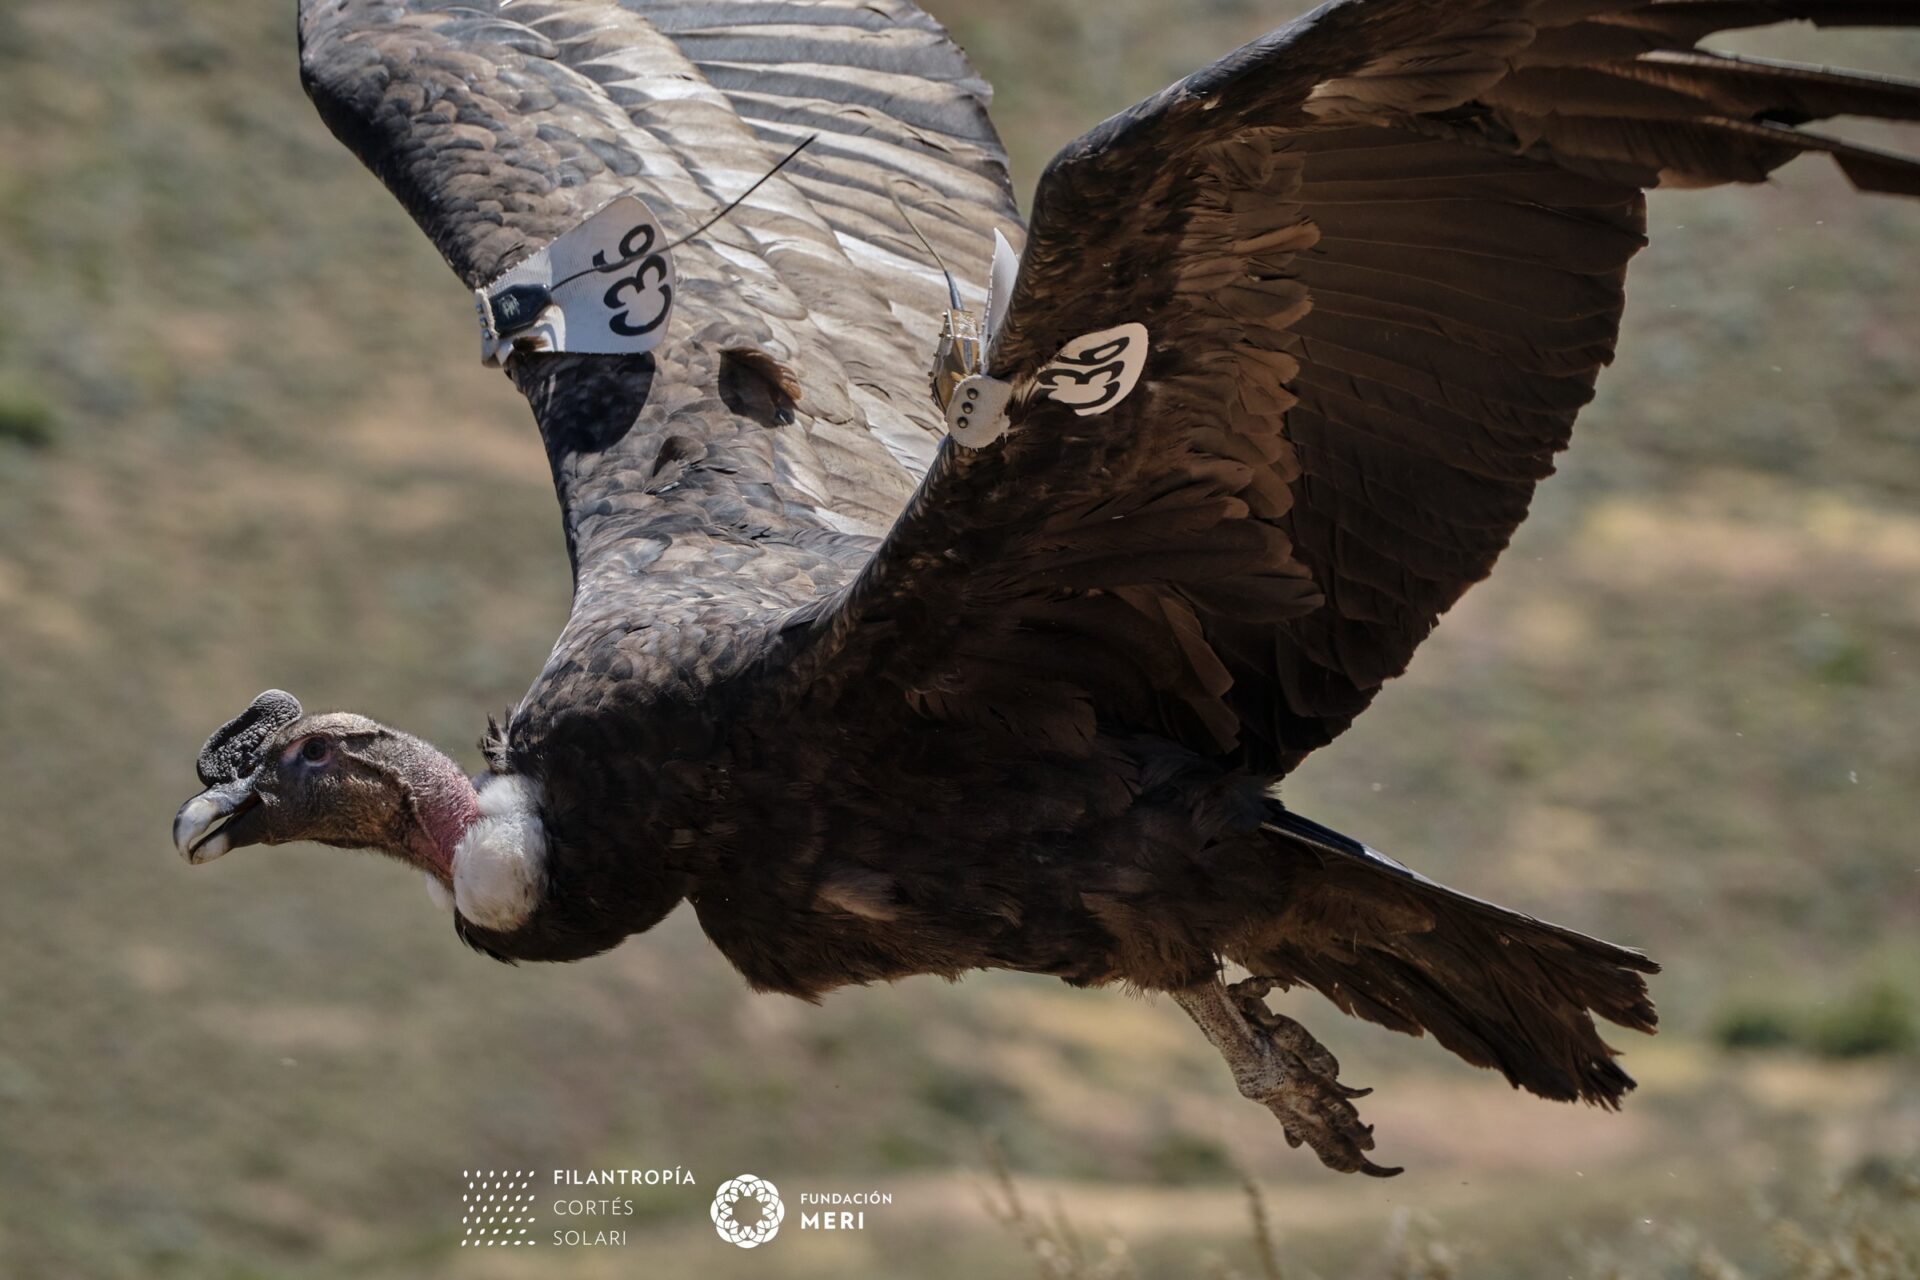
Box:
[0,0,1920,1280]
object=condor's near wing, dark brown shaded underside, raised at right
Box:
[783,0,1920,771]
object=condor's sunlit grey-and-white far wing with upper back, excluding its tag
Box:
[300,0,1052,782]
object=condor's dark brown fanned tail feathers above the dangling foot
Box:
[1227,802,1659,1107]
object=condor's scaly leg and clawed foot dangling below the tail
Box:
[1171,977,1400,1178]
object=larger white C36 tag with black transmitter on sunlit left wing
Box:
[474,196,674,365]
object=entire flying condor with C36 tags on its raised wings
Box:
[175,0,1920,1174]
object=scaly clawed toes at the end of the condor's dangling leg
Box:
[1227,977,1400,1178]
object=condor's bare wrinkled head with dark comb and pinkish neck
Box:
[173,691,478,887]
